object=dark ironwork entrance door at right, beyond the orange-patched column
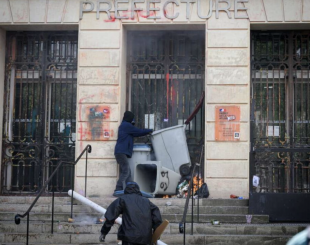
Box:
[250,31,310,220]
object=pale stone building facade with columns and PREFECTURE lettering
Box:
[0,0,310,202]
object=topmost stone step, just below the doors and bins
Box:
[0,196,249,207]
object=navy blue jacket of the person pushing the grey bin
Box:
[114,121,153,158]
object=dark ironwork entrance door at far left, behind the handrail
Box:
[2,32,77,193]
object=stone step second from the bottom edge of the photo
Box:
[0,221,307,236]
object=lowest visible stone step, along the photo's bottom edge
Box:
[0,233,291,245]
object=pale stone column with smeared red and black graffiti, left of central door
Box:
[76,12,121,196]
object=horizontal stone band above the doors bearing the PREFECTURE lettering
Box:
[0,0,310,25]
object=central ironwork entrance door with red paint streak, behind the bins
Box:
[127,31,205,161]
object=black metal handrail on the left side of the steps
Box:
[14,145,92,245]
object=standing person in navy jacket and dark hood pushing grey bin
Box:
[114,111,153,193]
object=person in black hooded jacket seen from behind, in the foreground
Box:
[99,182,162,245]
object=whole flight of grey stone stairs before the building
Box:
[0,196,307,245]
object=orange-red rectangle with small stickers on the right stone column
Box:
[215,106,240,141]
